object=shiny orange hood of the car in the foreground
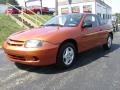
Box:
[9,27,68,41]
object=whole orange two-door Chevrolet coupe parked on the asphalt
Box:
[3,14,113,68]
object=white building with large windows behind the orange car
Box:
[58,0,112,20]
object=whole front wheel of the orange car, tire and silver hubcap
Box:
[56,43,77,69]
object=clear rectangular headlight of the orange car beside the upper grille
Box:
[25,40,42,48]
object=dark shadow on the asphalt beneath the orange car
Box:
[15,44,120,74]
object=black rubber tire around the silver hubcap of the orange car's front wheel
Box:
[56,43,77,69]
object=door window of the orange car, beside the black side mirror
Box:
[83,15,99,27]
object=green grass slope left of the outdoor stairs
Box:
[0,14,23,45]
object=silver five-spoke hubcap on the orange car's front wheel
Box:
[63,47,75,65]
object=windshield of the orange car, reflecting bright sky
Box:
[44,14,82,26]
